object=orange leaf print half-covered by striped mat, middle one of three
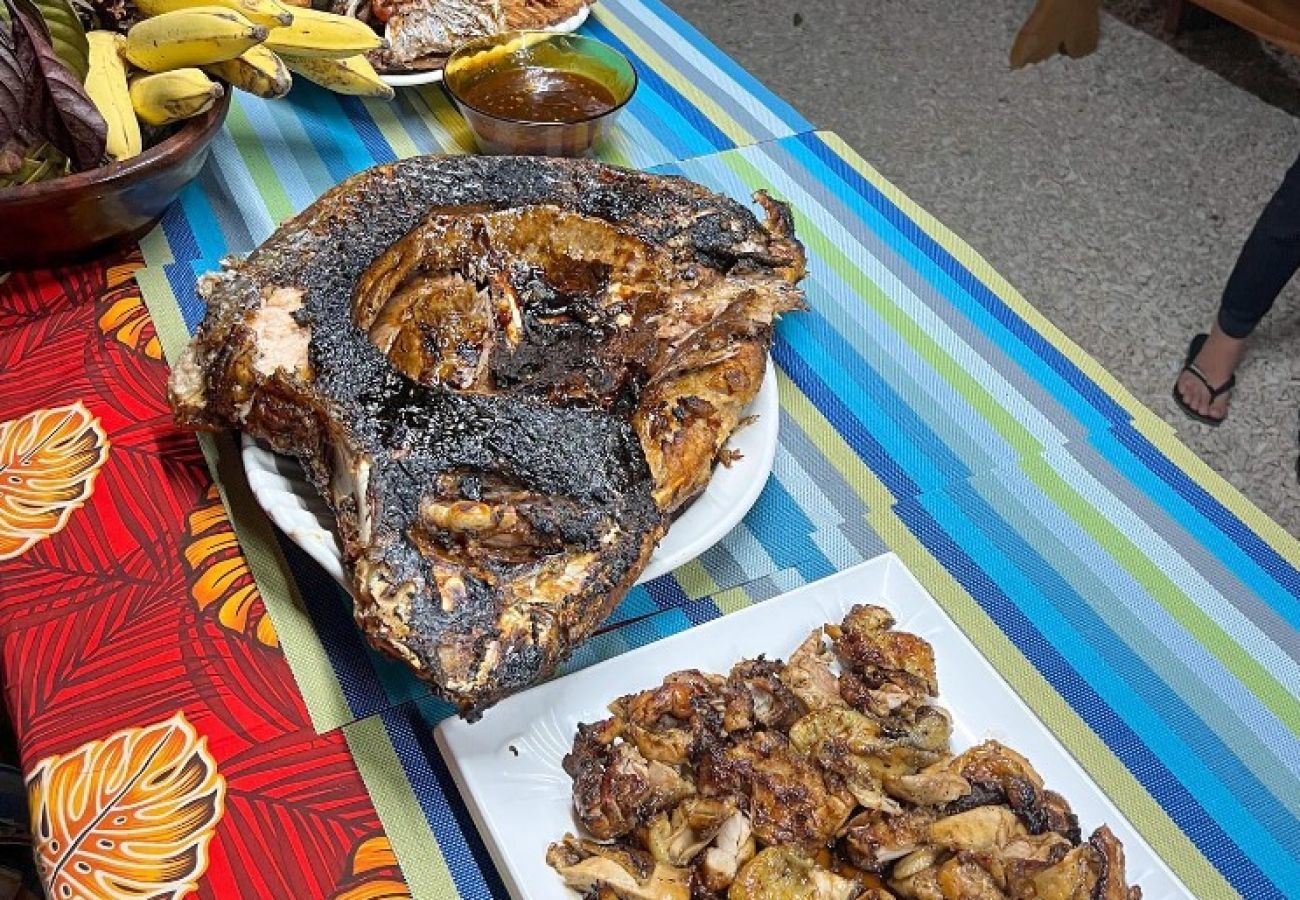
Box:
[185,485,280,646]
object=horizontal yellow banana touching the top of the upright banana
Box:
[126,7,267,72]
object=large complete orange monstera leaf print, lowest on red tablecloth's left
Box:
[27,713,226,900]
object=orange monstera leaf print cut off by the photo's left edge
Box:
[0,403,108,559]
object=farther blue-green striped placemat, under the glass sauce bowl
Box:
[137,0,811,731]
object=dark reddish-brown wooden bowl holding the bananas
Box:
[0,88,230,269]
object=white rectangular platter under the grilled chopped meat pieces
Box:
[436,554,1192,900]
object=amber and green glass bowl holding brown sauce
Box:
[442,31,637,156]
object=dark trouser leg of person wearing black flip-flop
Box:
[1218,152,1300,338]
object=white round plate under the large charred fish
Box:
[242,359,780,589]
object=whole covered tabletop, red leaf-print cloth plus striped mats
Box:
[0,0,1300,897]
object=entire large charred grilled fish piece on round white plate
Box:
[169,156,803,715]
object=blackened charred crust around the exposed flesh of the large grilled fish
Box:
[172,156,803,715]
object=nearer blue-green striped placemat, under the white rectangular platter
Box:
[317,134,1300,899]
